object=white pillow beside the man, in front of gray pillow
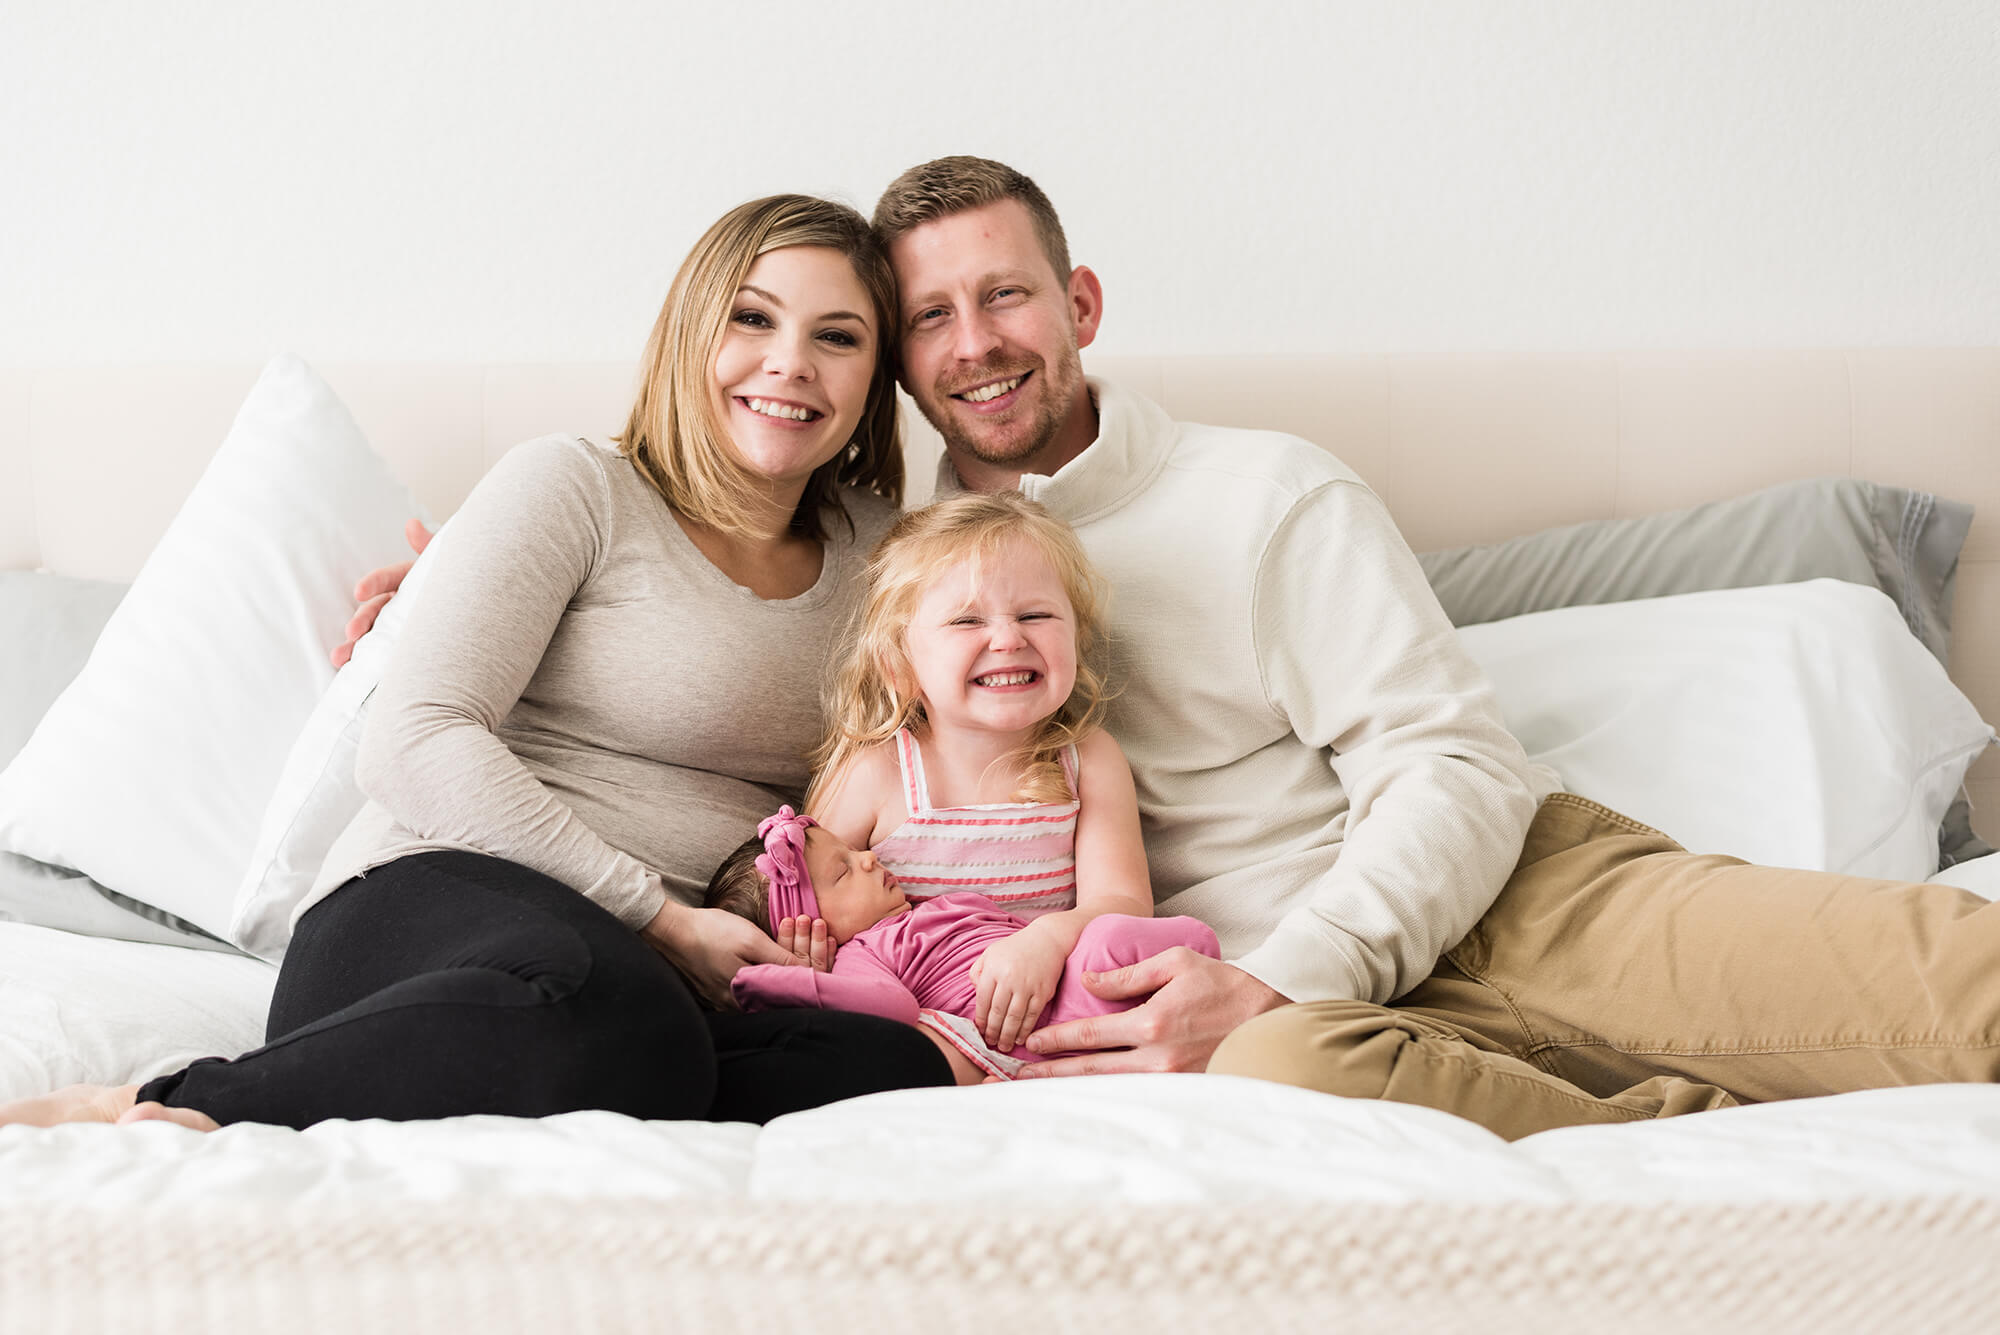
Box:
[1460,580,1994,881]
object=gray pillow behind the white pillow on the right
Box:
[1418,478,1992,867]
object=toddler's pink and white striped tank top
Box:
[874,727,1082,917]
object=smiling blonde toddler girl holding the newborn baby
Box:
[732,492,1216,1059]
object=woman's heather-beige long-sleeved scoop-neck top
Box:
[298,436,896,927]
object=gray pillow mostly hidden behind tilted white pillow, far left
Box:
[0,570,245,951]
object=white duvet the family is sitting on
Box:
[0,857,2000,1205]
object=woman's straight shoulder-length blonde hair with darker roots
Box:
[616,194,902,540]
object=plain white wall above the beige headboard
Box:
[0,0,2000,364]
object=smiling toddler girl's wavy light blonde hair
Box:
[806,492,1110,809]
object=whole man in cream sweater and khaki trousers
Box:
[356,158,2000,1137]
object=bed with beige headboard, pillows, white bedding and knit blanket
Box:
[0,350,2000,1331]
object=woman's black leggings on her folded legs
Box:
[138,853,952,1127]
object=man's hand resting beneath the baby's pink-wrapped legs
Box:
[1016,945,1290,1079]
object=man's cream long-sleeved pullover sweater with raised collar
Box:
[940,380,1558,1001]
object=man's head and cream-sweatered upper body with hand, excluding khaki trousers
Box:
[874,158,1536,1075]
